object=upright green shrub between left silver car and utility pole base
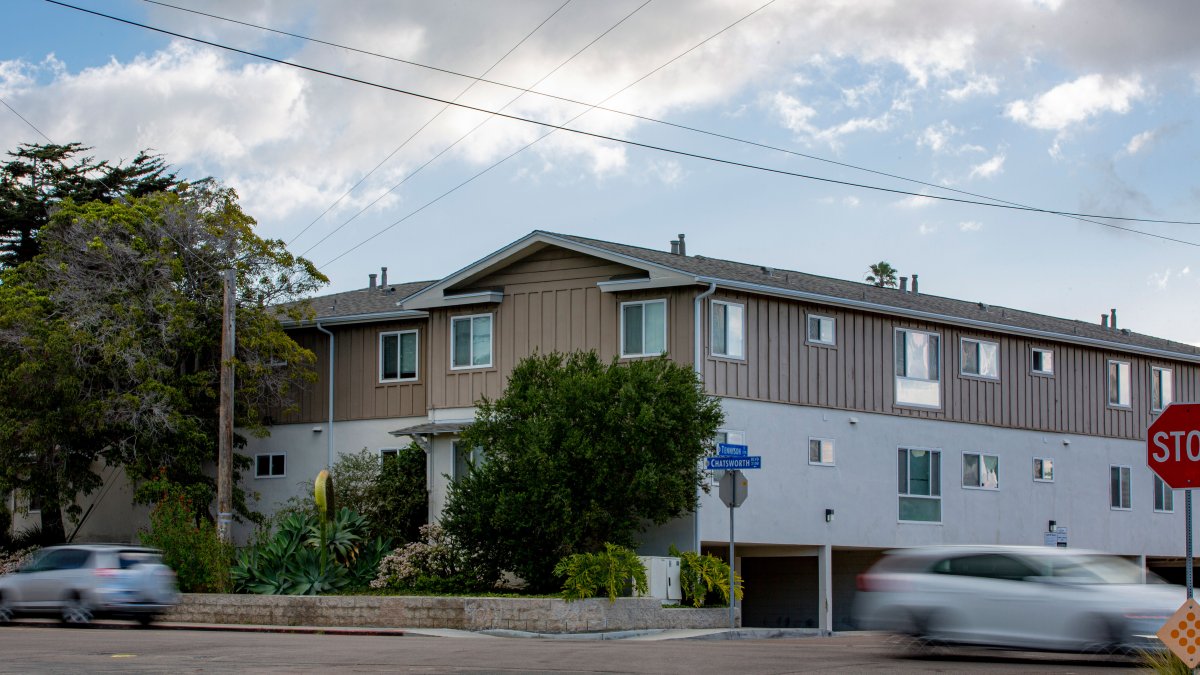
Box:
[138,480,233,593]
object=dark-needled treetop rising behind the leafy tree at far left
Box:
[0,143,179,268]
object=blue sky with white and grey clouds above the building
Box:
[0,0,1200,345]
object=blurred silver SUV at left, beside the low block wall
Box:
[0,544,179,625]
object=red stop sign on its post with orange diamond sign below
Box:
[1146,404,1200,669]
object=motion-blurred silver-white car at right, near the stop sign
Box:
[854,546,1186,651]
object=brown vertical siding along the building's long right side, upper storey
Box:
[704,291,1200,438]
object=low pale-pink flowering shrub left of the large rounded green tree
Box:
[371,525,488,593]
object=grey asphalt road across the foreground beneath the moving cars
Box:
[0,625,1135,675]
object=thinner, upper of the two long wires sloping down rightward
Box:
[143,0,1190,240]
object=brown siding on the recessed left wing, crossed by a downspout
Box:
[272,319,431,424]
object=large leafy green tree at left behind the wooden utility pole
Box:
[0,181,325,539]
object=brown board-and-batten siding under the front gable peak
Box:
[428,246,698,408]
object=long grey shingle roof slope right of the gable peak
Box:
[546,232,1200,357]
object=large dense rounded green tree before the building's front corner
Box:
[442,352,724,591]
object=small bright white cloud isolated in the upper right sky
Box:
[1004,74,1147,131]
